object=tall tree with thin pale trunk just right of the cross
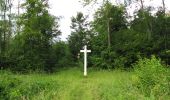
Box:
[91,2,127,68]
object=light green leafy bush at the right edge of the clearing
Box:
[133,56,170,99]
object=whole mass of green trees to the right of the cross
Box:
[90,2,170,69]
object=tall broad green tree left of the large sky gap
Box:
[10,0,60,71]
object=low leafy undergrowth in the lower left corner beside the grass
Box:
[0,72,56,100]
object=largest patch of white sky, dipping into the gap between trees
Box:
[49,0,100,41]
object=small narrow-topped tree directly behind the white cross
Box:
[68,12,91,61]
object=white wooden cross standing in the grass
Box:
[80,45,91,76]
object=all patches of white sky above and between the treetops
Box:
[14,0,170,41]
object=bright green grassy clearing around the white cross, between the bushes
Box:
[0,68,151,100]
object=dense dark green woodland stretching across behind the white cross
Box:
[0,0,170,72]
